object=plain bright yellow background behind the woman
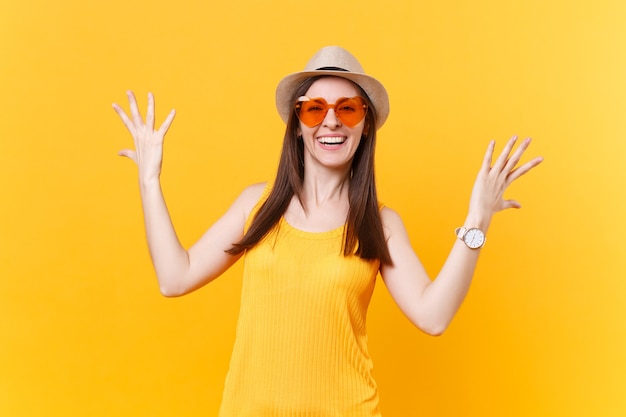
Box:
[0,0,626,417]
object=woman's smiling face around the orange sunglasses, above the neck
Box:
[298,77,366,171]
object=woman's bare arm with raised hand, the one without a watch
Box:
[113,91,263,297]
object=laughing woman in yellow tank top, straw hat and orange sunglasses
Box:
[113,47,542,417]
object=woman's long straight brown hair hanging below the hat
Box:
[227,77,391,264]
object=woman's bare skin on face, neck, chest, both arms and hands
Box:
[113,78,543,335]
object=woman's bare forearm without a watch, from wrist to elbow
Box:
[140,179,189,295]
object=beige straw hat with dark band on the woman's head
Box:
[276,46,389,129]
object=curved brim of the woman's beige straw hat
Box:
[276,70,389,129]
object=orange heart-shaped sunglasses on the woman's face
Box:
[296,96,367,127]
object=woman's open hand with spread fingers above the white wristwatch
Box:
[468,136,543,229]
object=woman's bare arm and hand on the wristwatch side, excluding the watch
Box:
[381,138,543,335]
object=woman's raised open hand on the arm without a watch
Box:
[113,91,176,182]
